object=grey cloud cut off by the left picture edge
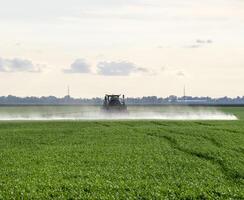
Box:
[0,58,43,72]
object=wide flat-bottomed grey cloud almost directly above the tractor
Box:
[97,61,148,76]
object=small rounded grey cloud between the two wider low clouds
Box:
[63,59,91,74]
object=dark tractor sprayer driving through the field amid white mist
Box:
[103,94,127,112]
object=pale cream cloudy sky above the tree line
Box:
[0,0,244,98]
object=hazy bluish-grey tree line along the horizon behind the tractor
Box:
[0,95,244,105]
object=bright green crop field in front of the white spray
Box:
[0,107,244,199]
